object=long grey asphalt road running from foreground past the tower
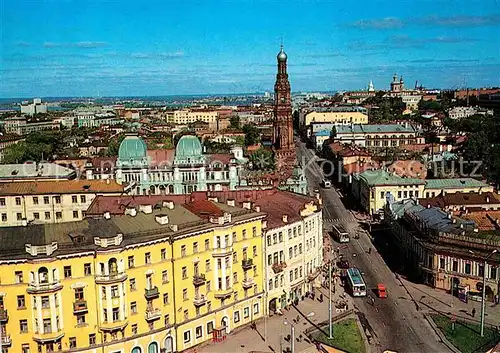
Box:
[297,142,448,353]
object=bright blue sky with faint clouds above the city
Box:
[0,0,500,98]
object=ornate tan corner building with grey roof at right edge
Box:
[384,199,500,301]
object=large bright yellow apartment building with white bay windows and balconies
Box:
[0,198,265,353]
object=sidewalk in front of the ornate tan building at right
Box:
[401,278,500,326]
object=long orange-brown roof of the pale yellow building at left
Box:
[0,180,125,196]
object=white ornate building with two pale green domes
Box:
[87,134,307,195]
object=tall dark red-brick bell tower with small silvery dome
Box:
[273,45,295,162]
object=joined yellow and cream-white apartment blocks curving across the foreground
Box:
[0,187,323,353]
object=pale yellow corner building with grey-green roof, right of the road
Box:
[352,169,425,215]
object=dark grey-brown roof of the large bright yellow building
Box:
[0,201,265,260]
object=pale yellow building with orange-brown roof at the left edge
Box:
[0,180,126,227]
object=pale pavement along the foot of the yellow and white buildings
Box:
[196,278,353,353]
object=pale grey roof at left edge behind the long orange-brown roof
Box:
[0,163,76,180]
